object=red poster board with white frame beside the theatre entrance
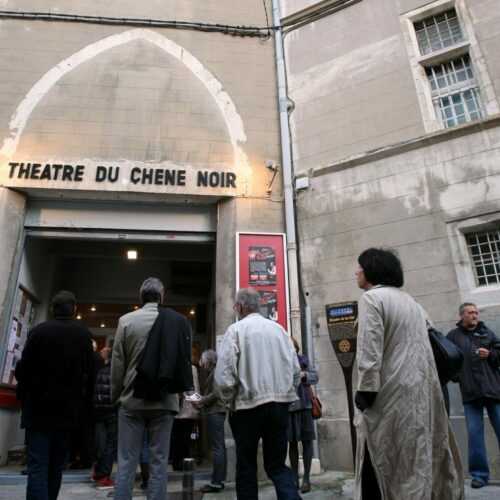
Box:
[236,231,291,334]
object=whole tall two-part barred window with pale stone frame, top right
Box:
[401,0,500,133]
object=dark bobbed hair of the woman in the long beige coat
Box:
[358,248,404,288]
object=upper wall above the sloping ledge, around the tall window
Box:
[285,0,500,173]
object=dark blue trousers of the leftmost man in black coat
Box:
[26,429,70,500]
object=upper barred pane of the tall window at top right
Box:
[414,9,463,56]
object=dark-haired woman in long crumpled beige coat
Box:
[355,248,463,500]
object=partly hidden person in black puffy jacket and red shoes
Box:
[92,348,118,490]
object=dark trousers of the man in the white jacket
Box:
[229,403,300,500]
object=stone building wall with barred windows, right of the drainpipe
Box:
[282,0,500,476]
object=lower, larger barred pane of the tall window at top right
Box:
[425,54,483,128]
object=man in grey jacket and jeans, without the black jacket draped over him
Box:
[111,278,183,500]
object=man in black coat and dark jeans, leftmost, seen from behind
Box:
[15,291,94,500]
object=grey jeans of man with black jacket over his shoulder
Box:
[114,407,174,500]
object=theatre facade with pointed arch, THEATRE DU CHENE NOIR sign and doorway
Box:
[0,0,284,463]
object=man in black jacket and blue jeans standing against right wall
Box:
[447,302,500,488]
